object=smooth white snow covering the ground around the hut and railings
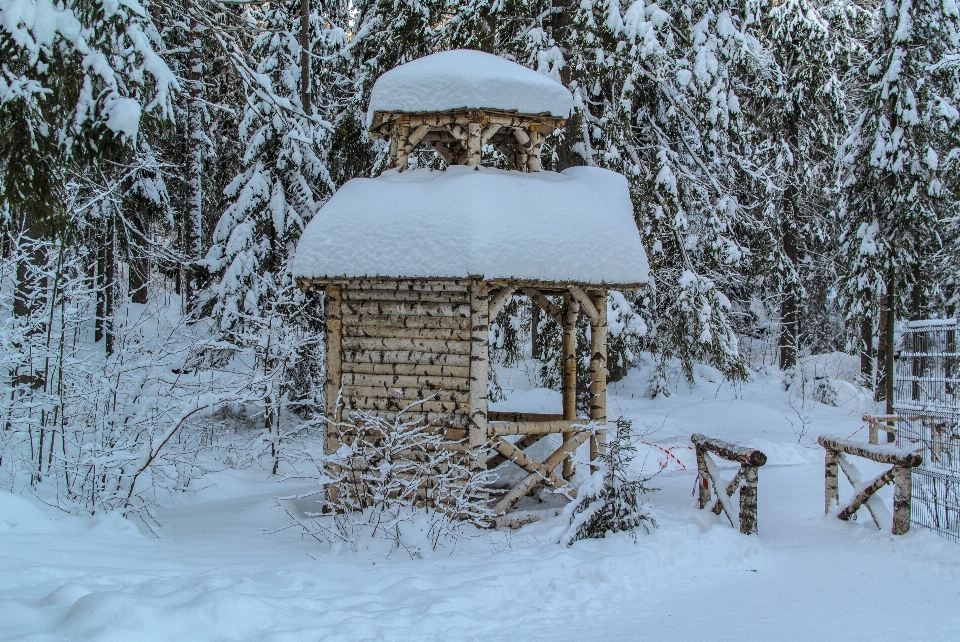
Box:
[0,358,960,641]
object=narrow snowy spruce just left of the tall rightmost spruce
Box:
[756,0,847,370]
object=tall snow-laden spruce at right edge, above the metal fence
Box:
[840,0,960,396]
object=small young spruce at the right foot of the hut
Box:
[560,417,657,546]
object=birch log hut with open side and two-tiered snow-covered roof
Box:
[292,51,649,514]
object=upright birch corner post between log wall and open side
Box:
[469,278,490,469]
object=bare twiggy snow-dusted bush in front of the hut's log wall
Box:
[287,401,496,556]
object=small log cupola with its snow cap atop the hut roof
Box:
[367,49,573,172]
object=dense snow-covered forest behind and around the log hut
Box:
[0,0,960,511]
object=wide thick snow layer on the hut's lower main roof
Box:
[292,165,649,286]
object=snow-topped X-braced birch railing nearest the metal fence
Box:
[817,435,922,535]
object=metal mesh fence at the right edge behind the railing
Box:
[893,319,960,541]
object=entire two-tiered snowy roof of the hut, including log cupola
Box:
[292,51,649,289]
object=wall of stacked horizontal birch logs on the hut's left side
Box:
[326,279,478,448]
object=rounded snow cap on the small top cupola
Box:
[367,49,573,124]
